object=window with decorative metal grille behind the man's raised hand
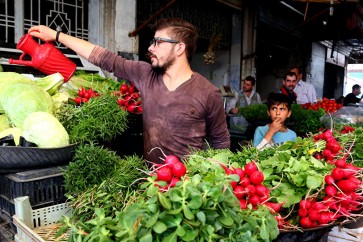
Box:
[0,0,88,48]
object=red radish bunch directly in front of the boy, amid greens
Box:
[220,162,282,213]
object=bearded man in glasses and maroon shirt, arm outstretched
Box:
[29,19,230,163]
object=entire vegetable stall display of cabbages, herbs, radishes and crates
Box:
[0,63,363,242]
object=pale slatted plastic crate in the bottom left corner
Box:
[13,196,71,242]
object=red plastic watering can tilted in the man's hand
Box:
[9,34,76,82]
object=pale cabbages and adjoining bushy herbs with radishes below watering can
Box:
[0,72,142,148]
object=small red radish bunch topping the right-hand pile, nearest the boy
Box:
[314,129,342,164]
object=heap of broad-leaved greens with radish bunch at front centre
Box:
[59,147,278,241]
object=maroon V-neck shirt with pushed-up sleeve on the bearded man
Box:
[88,46,230,163]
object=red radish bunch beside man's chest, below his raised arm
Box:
[114,83,142,114]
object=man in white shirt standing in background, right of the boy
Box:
[290,66,317,104]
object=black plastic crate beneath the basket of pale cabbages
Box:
[0,167,66,217]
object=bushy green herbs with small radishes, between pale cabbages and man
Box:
[56,72,146,143]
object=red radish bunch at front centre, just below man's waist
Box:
[152,155,187,192]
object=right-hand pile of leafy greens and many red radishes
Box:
[233,124,363,230]
